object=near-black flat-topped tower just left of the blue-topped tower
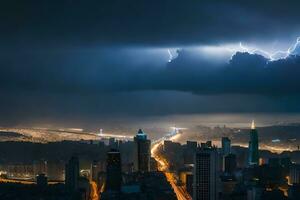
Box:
[105,149,122,191]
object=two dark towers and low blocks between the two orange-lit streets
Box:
[100,129,176,200]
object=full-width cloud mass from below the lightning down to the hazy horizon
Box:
[0,46,300,126]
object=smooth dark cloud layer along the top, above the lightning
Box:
[0,0,300,45]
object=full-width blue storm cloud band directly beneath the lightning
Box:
[0,49,300,96]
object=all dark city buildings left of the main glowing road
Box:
[0,129,176,200]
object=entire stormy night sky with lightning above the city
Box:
[0,0,300,126]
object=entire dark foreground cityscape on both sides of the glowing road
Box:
[0,122,300,200]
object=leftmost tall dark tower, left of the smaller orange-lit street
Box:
[65,156,79,191]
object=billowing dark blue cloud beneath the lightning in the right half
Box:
[151,51,300,96]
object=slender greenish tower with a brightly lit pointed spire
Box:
[248,120,259,166]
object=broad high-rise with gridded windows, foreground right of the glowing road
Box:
[193,148,219,200]
